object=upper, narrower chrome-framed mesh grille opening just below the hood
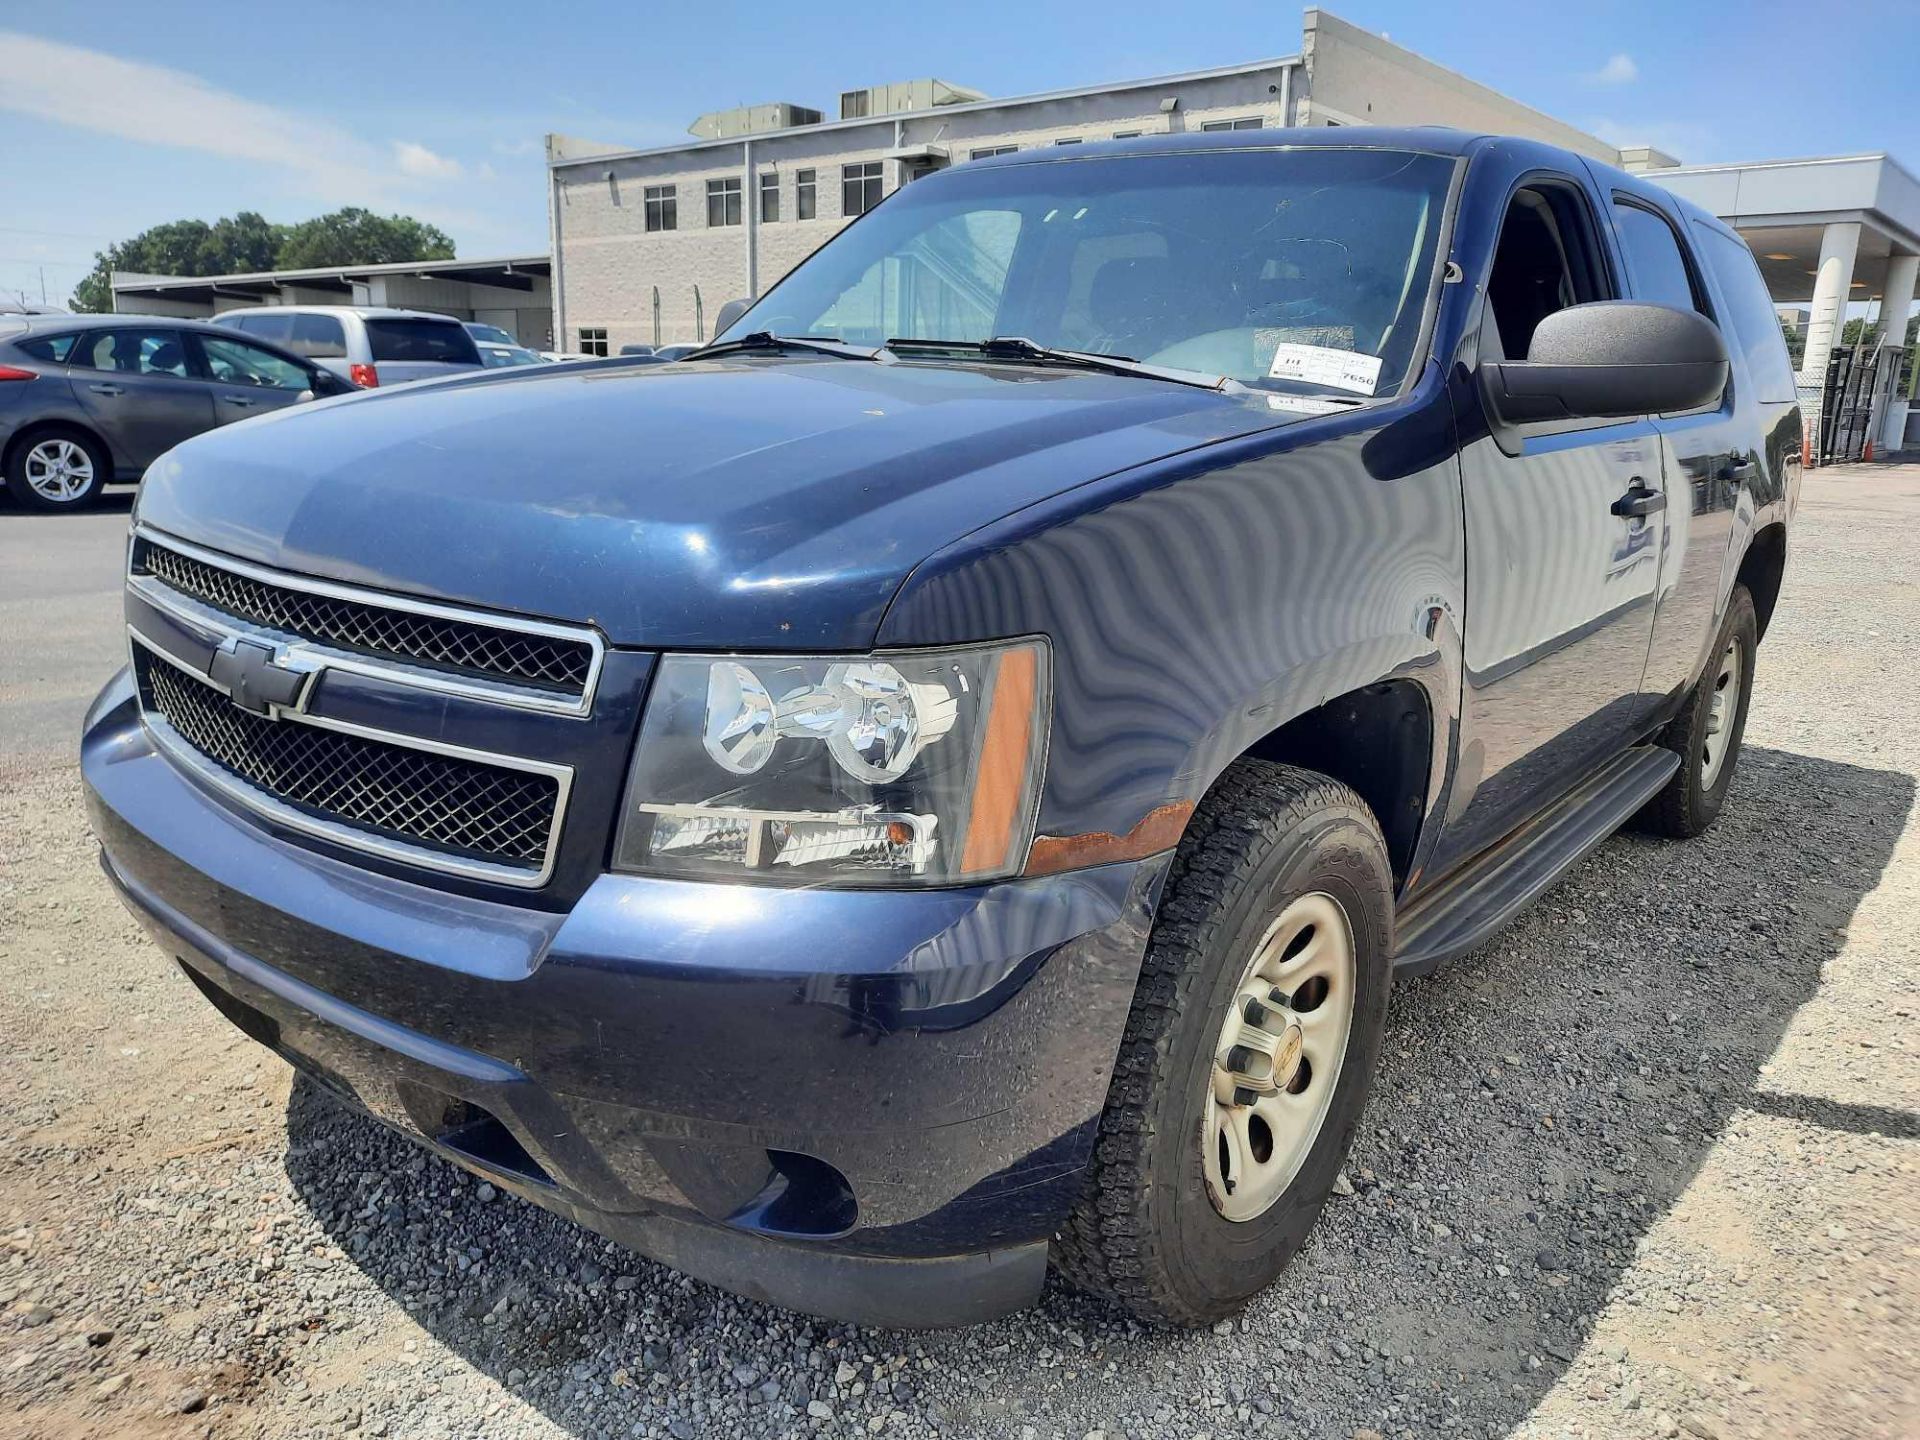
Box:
[131,534,601,712]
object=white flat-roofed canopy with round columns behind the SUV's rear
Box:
[1647,154,1920,451]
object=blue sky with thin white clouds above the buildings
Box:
[0,0,1920,303]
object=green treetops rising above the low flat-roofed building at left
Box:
[73,205,453,311]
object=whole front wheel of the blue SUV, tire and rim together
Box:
[1054,760,1394,1325]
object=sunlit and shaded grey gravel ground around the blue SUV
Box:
[0,467,1920,1440]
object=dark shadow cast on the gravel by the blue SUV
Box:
[288,749,1914,1436]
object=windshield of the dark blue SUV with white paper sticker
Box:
[720,148,1453,396]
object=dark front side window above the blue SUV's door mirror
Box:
[1480,184,1613,359]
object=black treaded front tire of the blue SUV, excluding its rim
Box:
[1054,760,1394,1325]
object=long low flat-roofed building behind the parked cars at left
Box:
[111,255,553,349]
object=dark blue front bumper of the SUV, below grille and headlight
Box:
[81,676,1165,1325]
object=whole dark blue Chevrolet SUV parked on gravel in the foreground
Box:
[83,129,1801,1325]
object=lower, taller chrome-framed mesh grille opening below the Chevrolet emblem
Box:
[132,643,568,885]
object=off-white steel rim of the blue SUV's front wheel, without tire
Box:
[1200,891,1357,1221]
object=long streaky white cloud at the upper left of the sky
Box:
[0,29,476,205]
